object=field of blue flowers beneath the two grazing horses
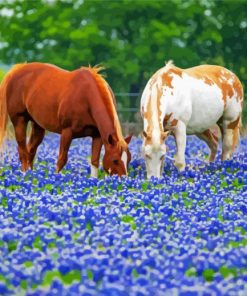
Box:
[0,134,247,296]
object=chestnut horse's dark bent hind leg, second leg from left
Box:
[27,122,45,169]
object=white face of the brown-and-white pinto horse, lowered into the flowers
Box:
[142,131,169,179]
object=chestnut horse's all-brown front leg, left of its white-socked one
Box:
[56,128,72,173]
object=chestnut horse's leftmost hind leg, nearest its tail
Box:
[12,116,28,172]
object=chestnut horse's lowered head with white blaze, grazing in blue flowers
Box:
[103,135,132,176]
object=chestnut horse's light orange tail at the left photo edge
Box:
[0,64,25,151]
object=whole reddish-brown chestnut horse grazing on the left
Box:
[0,63,131,177]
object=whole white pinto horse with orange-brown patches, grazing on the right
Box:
[141,61,243,178]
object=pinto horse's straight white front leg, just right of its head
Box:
[173,121,186,171]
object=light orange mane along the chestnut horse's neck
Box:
[81,66,127,149]
